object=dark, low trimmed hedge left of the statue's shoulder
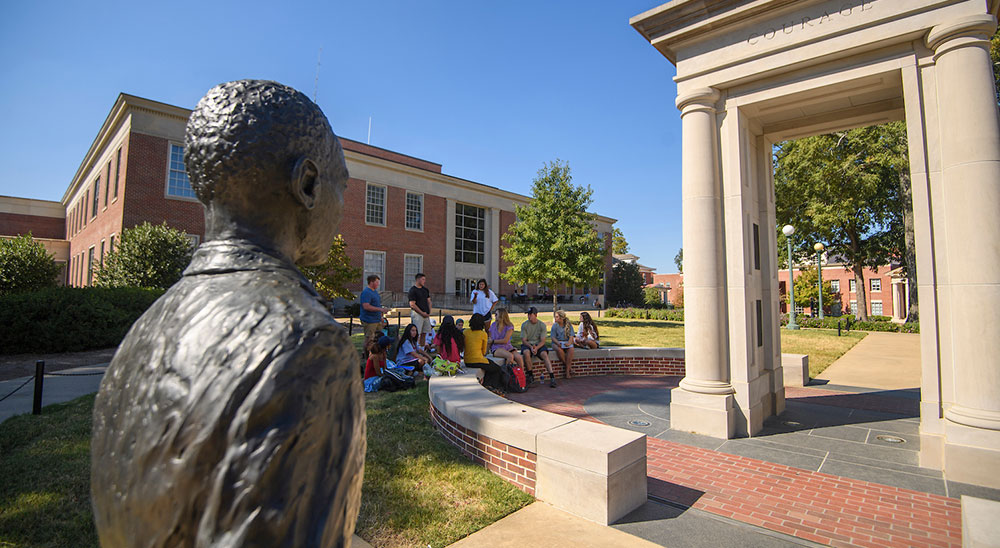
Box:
[0,287,163,354]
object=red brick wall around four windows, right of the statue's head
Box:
[340,178,447,293]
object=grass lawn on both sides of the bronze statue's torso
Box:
[0,383,532,548]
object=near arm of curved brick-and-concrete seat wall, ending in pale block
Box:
[428,373,646,525]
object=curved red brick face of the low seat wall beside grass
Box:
[430,403,538,496]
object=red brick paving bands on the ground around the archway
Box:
[510,377,961,547]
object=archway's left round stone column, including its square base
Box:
[670,88,734,438]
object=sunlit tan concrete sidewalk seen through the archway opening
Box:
[816,332,920,390]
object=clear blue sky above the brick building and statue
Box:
[0,0,681,272]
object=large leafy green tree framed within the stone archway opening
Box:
[774,122,912,320]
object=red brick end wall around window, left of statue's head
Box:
[119,133,205,239]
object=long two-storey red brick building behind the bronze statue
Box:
[0,94,615,306]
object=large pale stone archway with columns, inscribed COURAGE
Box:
[631,0,1000,487]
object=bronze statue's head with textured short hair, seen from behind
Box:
[184,80,348,264]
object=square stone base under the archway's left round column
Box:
[670,387,736,439]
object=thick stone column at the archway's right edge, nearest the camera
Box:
[927,14,1000,487]
